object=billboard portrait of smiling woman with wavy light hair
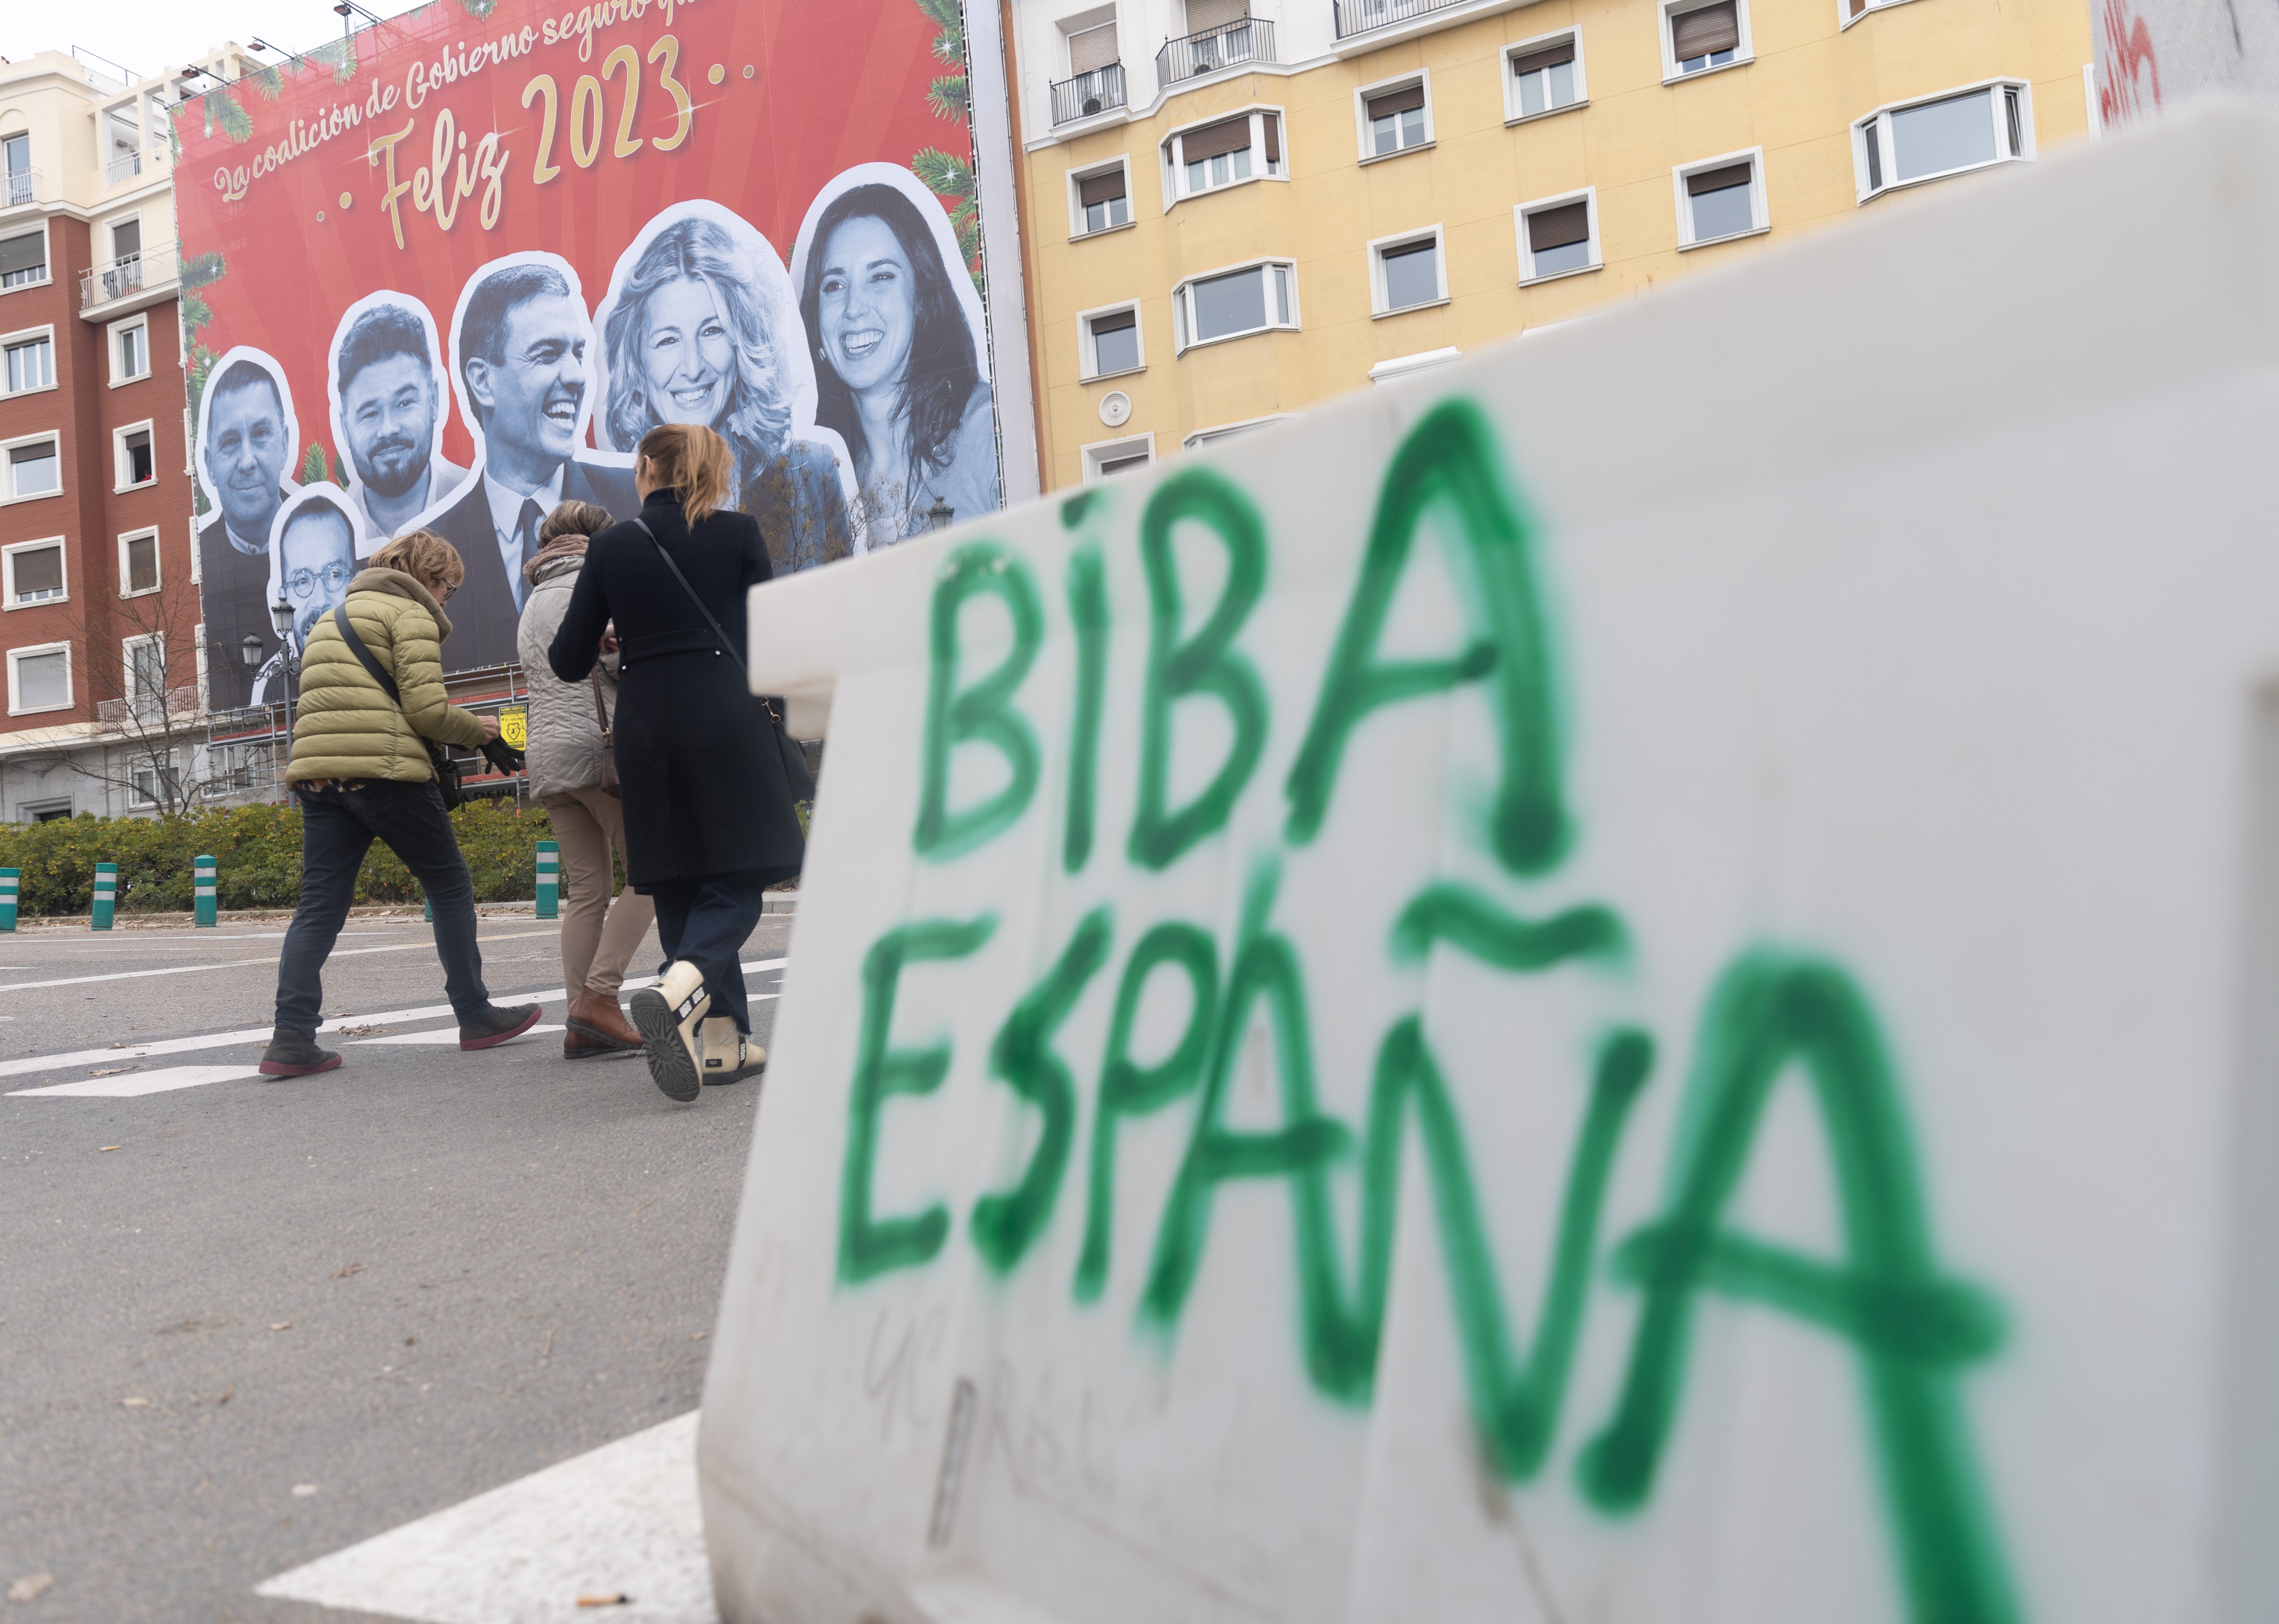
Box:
[602,214,852,574]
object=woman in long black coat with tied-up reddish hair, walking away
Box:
[547,423,807,1102]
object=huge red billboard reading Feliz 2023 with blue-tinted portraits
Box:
[175,0,1007,706]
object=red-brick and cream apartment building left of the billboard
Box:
[0,50,267,822]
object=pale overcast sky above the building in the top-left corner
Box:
[0,0,417,75]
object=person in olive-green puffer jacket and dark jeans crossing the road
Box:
[262,531,538,1078]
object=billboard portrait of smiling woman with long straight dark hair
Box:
[800,182,998,546]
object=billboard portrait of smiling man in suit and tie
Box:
[428,253,640,669]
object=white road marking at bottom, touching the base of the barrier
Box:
[253,1410,720,1624]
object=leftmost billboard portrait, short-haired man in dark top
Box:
[194,344,301,706]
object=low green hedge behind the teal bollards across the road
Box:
[0,802,554,916]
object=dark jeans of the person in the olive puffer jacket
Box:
[278,779,490,1037]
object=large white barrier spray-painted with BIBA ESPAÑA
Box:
[700,107,2279,1624]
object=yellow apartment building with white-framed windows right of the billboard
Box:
[1008,0,2092,490]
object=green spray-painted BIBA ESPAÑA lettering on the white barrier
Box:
[839,401,2022,1624]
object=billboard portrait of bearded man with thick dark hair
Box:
[326,292,467,546]
